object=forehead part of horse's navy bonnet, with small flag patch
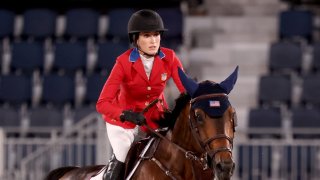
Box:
[191,81,230,117]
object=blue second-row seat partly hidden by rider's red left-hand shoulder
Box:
[95,41,128,73]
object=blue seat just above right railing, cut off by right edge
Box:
[291,107,320,139]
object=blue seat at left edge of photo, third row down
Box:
[0,75,32,106]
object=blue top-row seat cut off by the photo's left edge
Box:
[0,9,15,39]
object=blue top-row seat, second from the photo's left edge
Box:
[22,8,58,40]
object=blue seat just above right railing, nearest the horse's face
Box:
[248,107,283,138]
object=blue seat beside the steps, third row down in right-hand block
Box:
[258,75,292,107]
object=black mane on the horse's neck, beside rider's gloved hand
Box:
[156,93,191,130]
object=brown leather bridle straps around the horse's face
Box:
[189,93,233,161]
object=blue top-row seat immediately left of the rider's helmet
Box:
[107,8,135,42]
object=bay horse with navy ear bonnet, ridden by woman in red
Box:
[45,66,238,180]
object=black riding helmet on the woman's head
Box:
[128,9,167,43]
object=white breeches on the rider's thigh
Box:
[106,123,138,162]
